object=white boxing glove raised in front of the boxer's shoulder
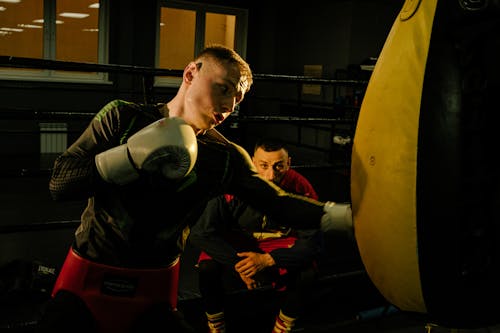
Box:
[95,117,198,185]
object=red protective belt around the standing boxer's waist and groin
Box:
[52,249,179,332]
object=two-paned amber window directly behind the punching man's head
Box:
[155,0,247,86]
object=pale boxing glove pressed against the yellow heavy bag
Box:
[321,201,354,238]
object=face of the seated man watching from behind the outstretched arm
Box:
[252,148,291,184]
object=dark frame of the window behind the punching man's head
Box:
[154,0,248,88]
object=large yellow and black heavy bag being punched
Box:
[351,0,500,328]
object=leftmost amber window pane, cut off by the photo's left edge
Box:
[0,0,43,58]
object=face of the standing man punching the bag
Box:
[185,60,243,130]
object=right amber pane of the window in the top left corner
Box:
[56,0,99,63]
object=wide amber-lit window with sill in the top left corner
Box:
[0,0,108,82]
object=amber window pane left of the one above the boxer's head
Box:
[158,7,196,70]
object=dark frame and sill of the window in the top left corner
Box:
[0,0,110,83]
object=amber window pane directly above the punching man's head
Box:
[205,13,236,49]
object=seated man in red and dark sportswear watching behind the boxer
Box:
[190,139,322,333]
